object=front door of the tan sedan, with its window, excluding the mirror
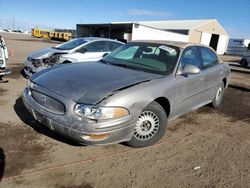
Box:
[174,46,205,116]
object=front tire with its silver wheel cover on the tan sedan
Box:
[126,102,167,148]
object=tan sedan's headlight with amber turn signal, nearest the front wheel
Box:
[74,104,129,120]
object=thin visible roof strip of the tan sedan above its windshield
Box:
[131,40,210,48]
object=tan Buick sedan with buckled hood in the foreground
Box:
[22,41,230,147]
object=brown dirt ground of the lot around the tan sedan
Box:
[0,33,250,188]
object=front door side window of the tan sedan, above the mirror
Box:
[181,47,202,68]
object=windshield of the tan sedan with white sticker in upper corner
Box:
[103,42,179,75]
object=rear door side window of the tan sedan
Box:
[200,47,218,68]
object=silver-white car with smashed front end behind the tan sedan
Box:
[23,37,123,77]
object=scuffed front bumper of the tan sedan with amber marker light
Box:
[22,88,137,145]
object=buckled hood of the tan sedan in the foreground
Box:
[31,62,162,104]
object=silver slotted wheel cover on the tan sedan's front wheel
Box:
[134,111,160,141]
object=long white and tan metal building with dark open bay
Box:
[76,19,229,54]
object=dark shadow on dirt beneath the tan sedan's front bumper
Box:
[14,97,83,146]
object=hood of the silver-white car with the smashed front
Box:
[29,48,69,59]
